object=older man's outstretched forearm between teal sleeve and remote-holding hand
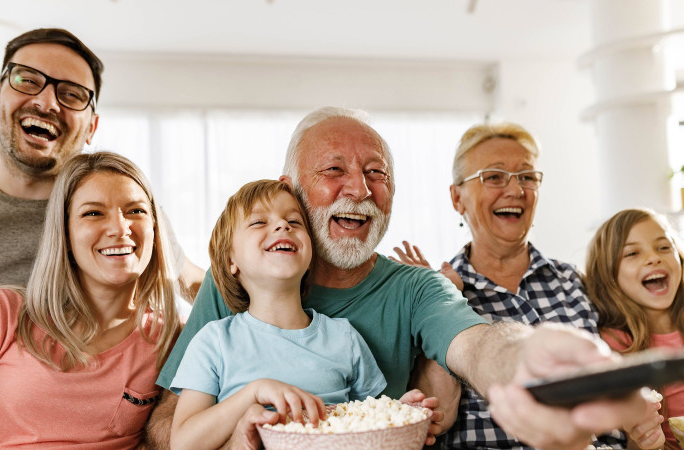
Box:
[447,322,533,396]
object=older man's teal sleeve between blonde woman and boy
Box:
[157,269,232,389]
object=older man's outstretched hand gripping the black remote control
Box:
[487,324,646,449]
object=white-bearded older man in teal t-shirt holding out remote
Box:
[148,108,643,448]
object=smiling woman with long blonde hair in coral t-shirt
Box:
[0,152,179,449]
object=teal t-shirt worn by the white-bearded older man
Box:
[157,255,487,398]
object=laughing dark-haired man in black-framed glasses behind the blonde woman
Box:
[0,28,204,297]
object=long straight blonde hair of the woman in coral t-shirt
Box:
[17,152,180,371]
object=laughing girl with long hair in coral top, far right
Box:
[585,209,684,448]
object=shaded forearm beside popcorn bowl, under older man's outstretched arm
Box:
[408,354,461,434]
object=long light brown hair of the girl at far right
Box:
[584,209,684,353]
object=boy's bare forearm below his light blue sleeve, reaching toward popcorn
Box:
[171,382,256,449]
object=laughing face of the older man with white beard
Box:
[296,117,392,269]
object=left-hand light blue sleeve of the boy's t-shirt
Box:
[171,321,225,397]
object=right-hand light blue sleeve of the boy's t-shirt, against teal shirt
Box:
[349,324,387,401]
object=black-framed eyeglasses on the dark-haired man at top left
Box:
[0,62,95,111]
